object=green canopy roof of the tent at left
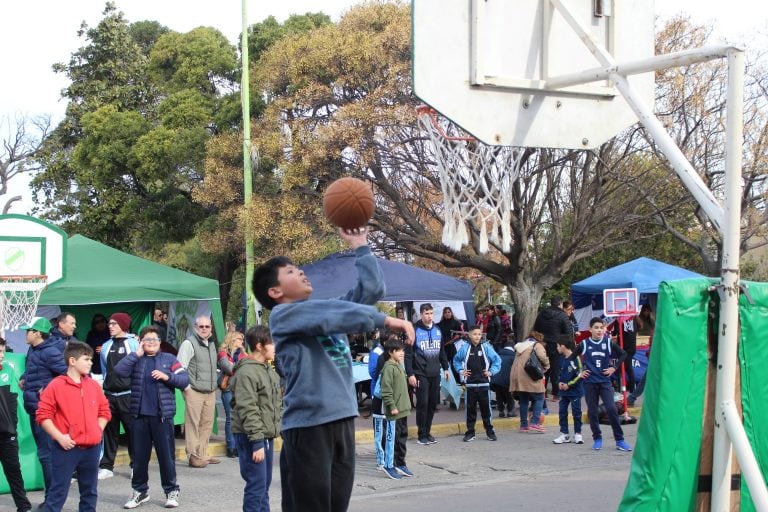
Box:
[40,235,219,305]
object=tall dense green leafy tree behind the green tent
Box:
[34,3,237,251]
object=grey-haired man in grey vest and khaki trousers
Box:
[177,316,221,468]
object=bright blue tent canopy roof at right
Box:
[571,258,704,308]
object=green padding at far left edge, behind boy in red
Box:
[0,353,44,494]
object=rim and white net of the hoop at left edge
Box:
[0,275,48,330]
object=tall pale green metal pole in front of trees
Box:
[240,0,256,328]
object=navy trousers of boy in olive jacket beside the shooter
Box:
[234,434,274,512]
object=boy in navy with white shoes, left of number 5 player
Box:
[552,339,584,444]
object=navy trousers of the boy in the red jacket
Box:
[45,443,101,512]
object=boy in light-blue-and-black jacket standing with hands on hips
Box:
[453,326,501,442]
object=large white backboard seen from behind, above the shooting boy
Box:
[412,0,654,149]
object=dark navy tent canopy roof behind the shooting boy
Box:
[301,252,474,302]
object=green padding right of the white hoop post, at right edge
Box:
[739,282,768,511]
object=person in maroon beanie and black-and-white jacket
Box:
[99,313,139,480]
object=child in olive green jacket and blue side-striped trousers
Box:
[380,340,413,480]
